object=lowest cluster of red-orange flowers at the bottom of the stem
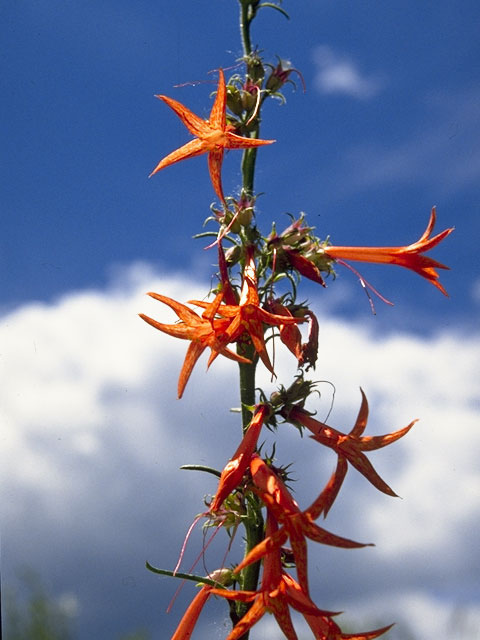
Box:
[166,391,415,640]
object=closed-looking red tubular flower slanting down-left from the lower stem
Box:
[209,404,270,513]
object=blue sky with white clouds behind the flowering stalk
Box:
[0,0,480,640]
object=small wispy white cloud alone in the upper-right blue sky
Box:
[314,45,384,100]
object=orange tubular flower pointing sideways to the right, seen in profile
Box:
[324,207,453,296]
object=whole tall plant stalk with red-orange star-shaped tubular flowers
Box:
[140,0,452,640]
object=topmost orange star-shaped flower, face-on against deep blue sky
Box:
[149,69,275,204]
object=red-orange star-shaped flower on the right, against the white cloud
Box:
[287,389,417,500]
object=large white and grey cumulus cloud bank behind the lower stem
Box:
[0,265,480,640]
